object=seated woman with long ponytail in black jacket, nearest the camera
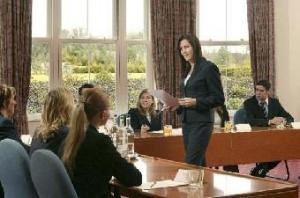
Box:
[62,88,142,198]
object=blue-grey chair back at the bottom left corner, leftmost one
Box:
[0,139,38,198]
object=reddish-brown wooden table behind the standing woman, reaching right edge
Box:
[134,128,300,167]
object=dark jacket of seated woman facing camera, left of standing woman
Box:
[128,108,162,131]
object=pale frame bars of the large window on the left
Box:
[29,0,154,117]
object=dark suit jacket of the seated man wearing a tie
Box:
[244,96,294,127]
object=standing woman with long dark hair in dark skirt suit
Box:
[177,34,224,166]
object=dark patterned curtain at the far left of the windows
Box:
[0,0,32,134]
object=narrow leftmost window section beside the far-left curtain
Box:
[27,0,51,114]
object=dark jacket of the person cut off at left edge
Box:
[0,115,29,151]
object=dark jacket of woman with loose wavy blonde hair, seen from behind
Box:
[30,125,69,155]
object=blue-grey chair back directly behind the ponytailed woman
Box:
[30,149,77,198]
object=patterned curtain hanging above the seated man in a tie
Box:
[247,0,276,94]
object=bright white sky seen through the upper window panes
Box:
[33,0,248,41]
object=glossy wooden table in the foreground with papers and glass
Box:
[112,156,298,198]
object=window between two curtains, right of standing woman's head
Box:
[198,0,253,109]
